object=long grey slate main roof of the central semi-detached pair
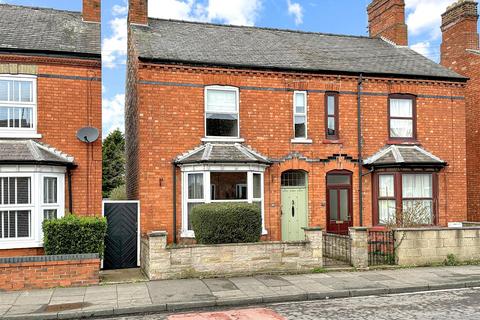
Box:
[131,19,466,81]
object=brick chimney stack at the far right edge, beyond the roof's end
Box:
[440,0,479,69]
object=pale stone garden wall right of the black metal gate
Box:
[395,227,480,265]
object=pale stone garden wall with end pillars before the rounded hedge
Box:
[141,228,323,280]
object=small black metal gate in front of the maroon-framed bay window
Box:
[368,230,395,266]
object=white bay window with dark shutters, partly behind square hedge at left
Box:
[0,166,65,249]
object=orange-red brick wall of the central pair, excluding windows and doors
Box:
[126,62,466,241]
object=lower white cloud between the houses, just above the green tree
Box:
[102,94,125,137]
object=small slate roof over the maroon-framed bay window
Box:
[363,145,447,168]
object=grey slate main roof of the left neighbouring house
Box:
[0,4,101,57]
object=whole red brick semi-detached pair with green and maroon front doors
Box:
[126,0,467,242]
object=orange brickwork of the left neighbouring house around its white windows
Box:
[0,55,102,256]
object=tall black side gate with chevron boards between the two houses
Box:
[103,201,139,269]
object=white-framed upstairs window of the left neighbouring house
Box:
[0,76,36,133]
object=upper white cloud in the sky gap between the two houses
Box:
[102,4,128,68]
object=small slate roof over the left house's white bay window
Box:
[0,140,74,166]
